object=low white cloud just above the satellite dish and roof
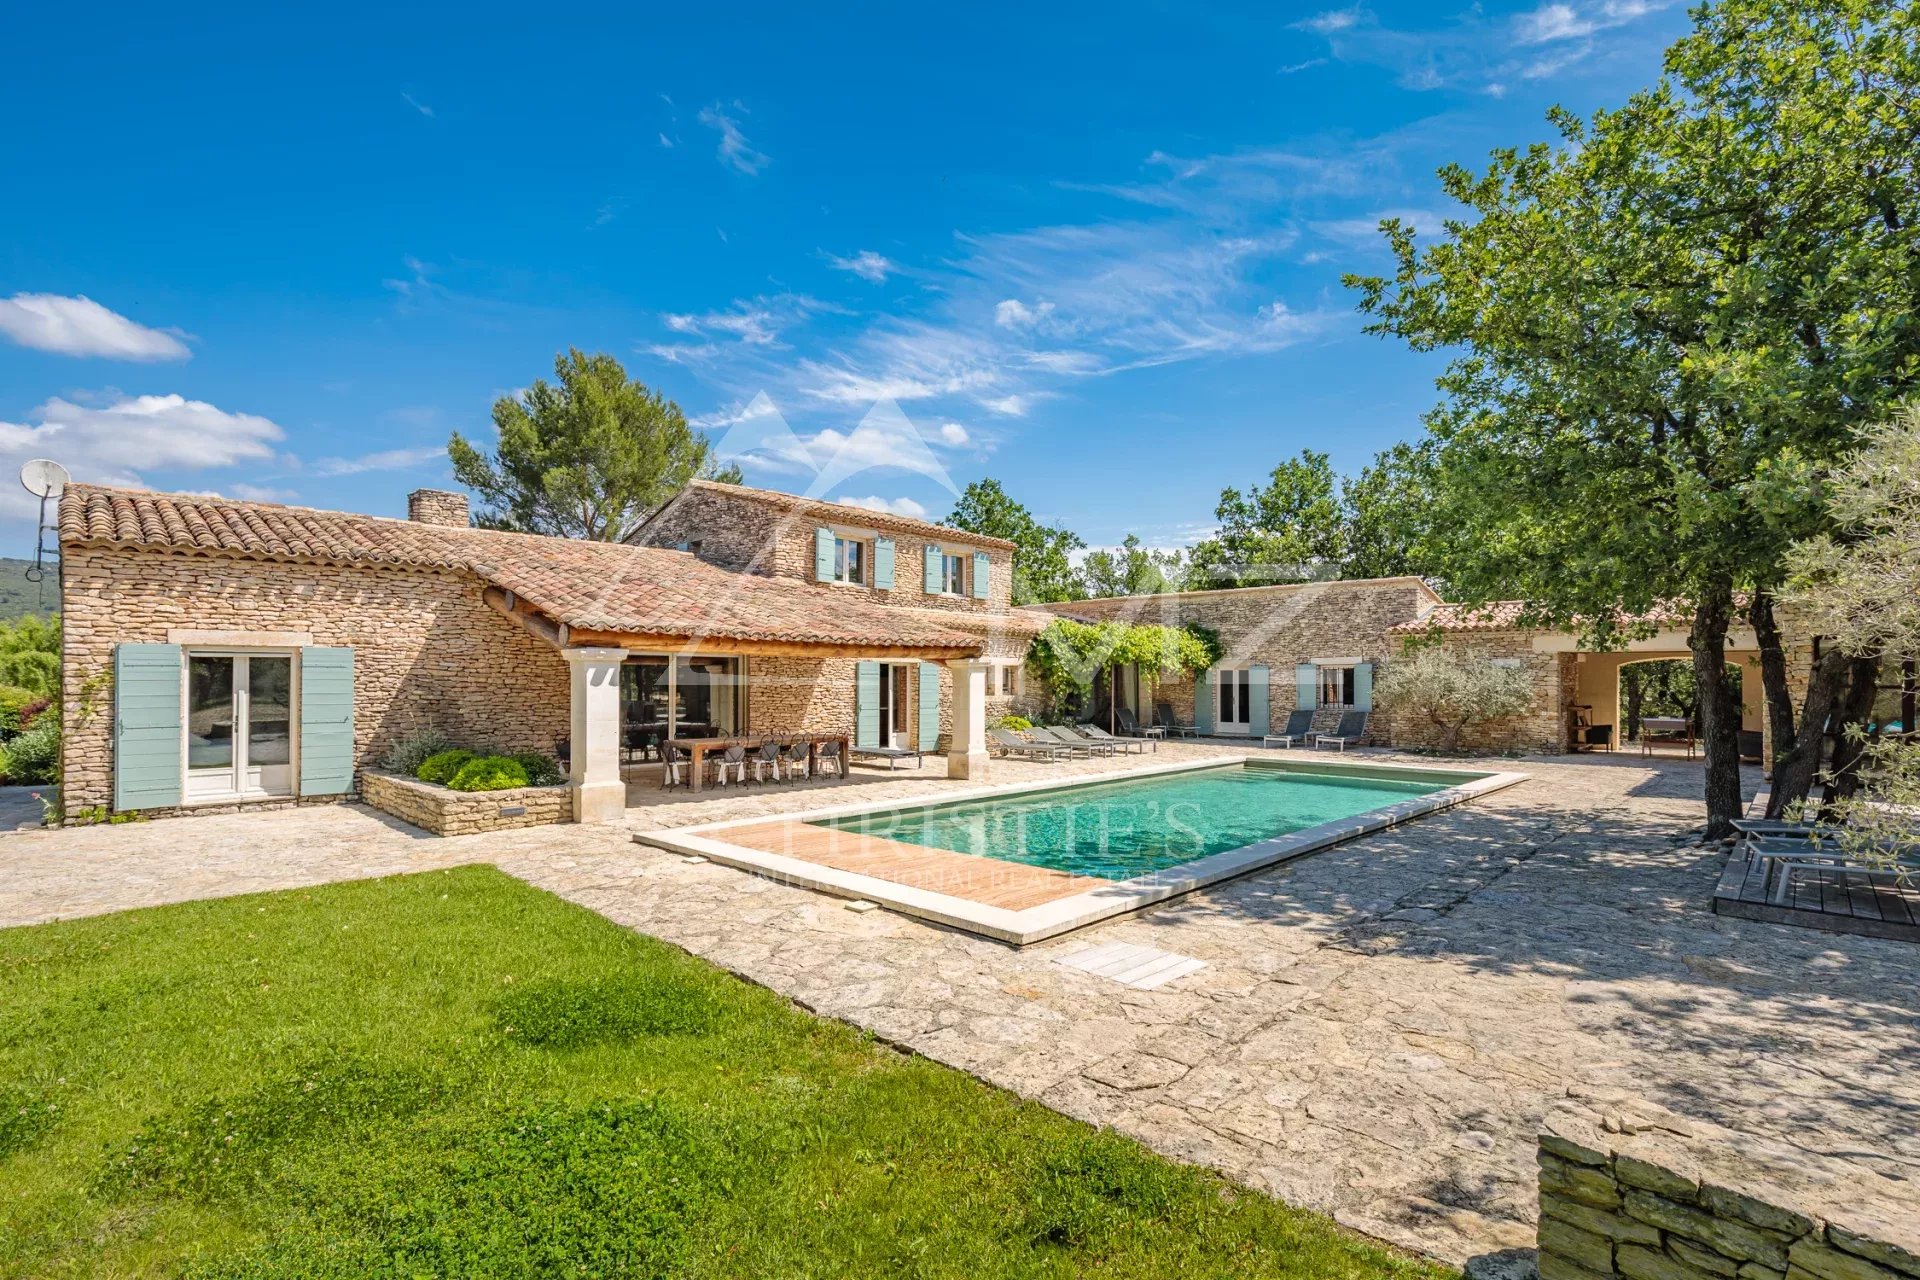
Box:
[0,393,286,516]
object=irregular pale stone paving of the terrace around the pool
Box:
[0,745,1920,1263]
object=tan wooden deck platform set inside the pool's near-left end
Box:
[726,819,1114,912]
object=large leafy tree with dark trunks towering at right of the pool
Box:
[1350,0,1920,835]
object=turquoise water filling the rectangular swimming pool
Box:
[812,764,1465,881]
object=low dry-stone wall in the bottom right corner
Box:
[1540,1109,1920,1280]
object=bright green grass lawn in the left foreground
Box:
[0,867,1446,1280]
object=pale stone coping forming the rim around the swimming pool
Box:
[634,756,1528,946]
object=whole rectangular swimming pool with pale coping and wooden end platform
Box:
[634,754,1526,946]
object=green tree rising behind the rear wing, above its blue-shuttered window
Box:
[1188,449,1346,589]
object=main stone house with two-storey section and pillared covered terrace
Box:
[60,482,1037,821]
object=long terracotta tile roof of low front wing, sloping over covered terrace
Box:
[60,484,985,656]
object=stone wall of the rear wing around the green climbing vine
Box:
[1048,578,1434,743]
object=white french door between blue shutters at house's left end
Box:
[186,652,294,802]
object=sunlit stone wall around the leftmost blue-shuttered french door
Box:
[61,547,570,816]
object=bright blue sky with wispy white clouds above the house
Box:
[0,0,1686,555]
